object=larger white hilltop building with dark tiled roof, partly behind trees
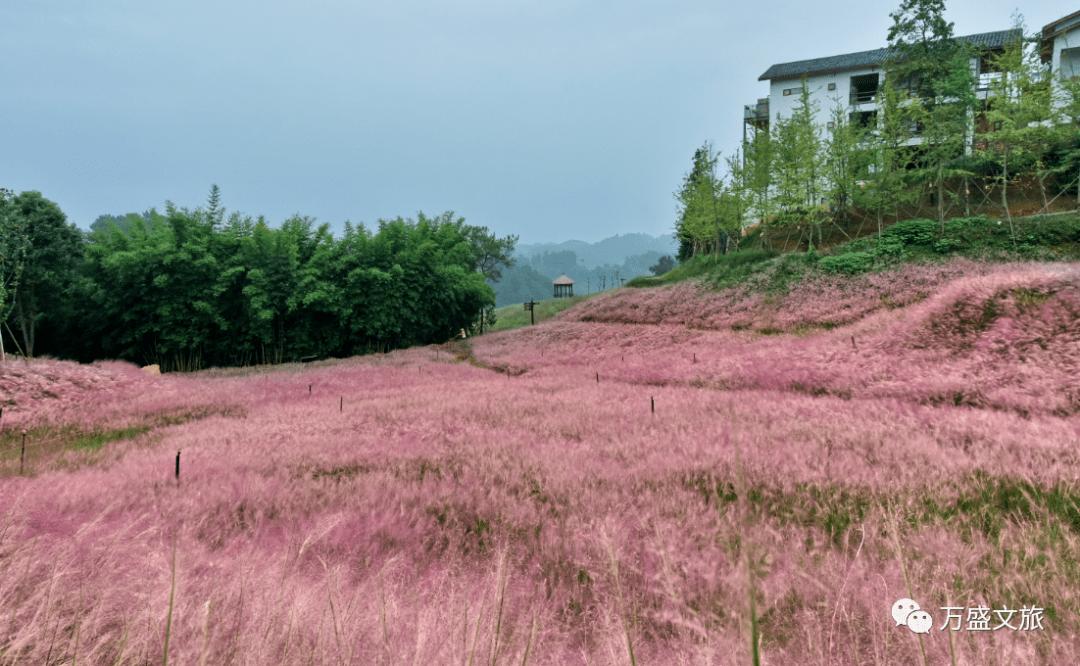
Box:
[743,29,1019,135]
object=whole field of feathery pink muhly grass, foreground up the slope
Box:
[0,256,1080,666]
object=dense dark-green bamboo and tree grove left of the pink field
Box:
[0,186,517,370]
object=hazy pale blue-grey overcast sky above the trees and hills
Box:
[0,0,1058,243]
